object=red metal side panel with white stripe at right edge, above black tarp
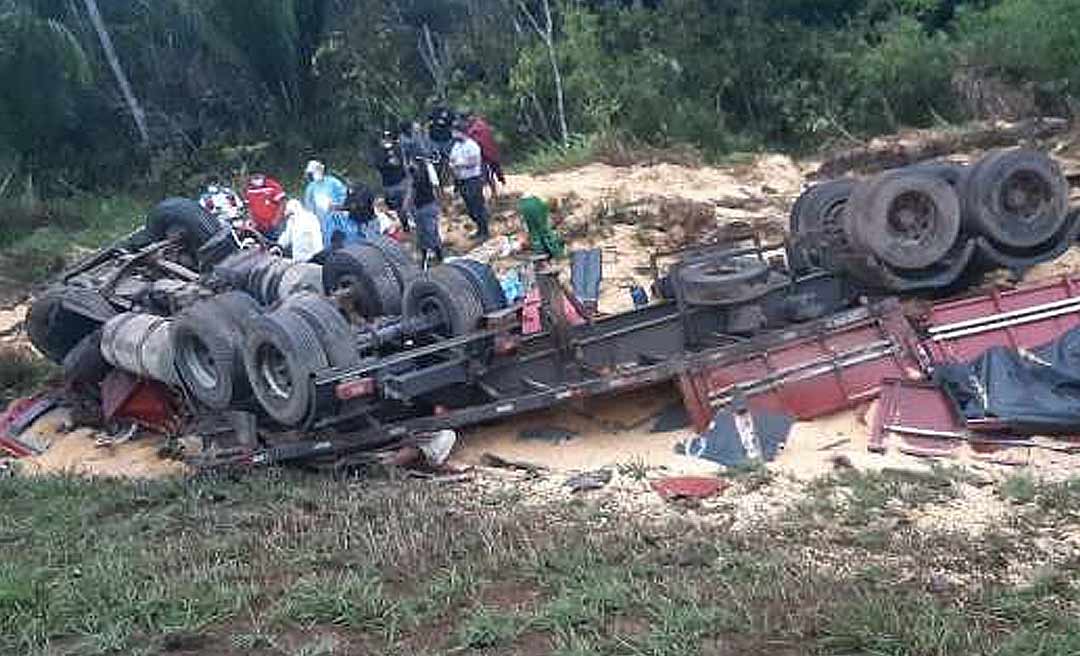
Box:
[926,278,1080,362]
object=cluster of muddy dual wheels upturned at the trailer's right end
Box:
[789,149,1080,293]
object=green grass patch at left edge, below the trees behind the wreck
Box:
[0,196,149,283]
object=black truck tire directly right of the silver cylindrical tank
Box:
[173,292,262,410]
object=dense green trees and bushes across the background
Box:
[0,0,1080,197]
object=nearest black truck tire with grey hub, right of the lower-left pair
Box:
[244,311,329,427]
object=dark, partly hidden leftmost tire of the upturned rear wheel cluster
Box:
[788,178,856,270]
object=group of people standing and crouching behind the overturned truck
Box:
[221,107,505,267]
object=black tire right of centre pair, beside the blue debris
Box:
[404,265,484,337]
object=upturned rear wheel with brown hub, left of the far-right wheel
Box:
[843,169,960,270]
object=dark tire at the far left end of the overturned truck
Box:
[26,286,117,364]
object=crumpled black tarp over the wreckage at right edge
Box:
[934,329,1080,434]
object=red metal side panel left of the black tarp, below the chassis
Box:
[684,309,920,429]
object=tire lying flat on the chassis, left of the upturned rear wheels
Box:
[678,257,769,305]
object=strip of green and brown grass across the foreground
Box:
[6,471,1080,656]
